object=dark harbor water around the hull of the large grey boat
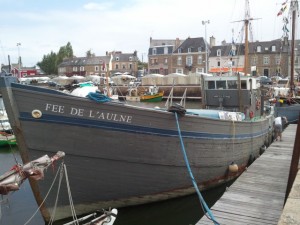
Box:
[0,101,230,225]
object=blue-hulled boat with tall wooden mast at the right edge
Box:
[275,0,300,123]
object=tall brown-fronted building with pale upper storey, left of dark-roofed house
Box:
[148,37,183,75]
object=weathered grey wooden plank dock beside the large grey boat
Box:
[196,124,300,225]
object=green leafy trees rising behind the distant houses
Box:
[37,42,73,74]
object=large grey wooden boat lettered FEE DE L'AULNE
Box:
[0,73,273,221]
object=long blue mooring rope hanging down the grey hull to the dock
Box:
[175,112,220,225]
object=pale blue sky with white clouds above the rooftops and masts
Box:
[0,0,296,67]
